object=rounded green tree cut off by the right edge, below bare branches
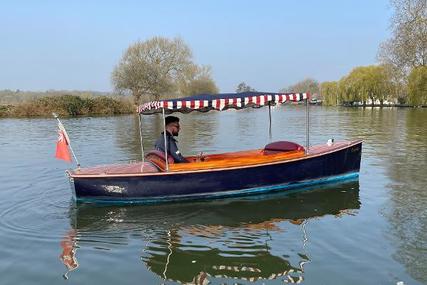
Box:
[408,66,427,106]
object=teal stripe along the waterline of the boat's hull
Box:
[76,172,359,204]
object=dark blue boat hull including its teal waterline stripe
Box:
[70,141,362,203]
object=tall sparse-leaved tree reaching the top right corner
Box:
[378,0,427,75]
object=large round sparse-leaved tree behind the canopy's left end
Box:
[111,37,194,104]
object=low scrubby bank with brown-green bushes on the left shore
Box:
[0,95,135,118]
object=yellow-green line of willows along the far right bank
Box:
[280,64,427,106]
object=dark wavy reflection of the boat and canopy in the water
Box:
[61,181,360,284]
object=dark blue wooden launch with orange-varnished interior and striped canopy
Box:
[67,92,362,203]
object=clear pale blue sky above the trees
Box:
[0,0,392,92]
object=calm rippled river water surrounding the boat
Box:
[0,106,427,285]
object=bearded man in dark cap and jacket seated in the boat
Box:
[154,116,188,163]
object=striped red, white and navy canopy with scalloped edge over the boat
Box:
[137,92,310,115]
